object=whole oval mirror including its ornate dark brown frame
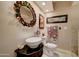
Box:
[14,1,36,27]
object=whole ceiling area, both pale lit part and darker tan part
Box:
[34,1,72,13]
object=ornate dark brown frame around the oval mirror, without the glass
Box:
[14,1,36,27]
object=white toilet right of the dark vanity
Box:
[43,37,57,57]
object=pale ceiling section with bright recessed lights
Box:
[34,1,53,13]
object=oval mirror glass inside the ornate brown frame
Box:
[20,6,33,23]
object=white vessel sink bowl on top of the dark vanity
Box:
[26,37,42,48]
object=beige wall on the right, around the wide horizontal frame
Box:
[46,4,79,52]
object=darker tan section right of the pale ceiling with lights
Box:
[53,1,73,12]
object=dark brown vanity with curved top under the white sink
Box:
[15,43,43,57]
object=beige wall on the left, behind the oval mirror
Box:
[0,1,44,56]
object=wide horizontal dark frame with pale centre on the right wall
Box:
[46,15,68,24]
